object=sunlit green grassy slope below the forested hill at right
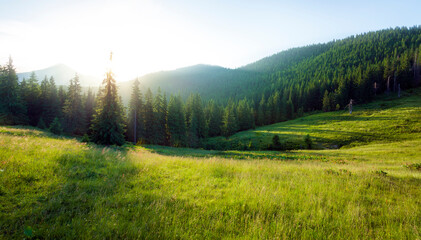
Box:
[205,89,421,149]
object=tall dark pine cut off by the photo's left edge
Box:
[0,57,27,125]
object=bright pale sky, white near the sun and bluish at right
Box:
[0,0,421,81]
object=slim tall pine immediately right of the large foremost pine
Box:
[127,79,144,143]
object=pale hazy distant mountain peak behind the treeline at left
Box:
[18,64,101,86]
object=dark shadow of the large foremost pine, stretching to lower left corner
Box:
[0,143,138,239]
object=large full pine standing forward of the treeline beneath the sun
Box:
[91,67,125,146]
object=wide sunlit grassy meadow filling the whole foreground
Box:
[0,124,421,239]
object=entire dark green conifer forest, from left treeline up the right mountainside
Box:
[0,27,421,148]
